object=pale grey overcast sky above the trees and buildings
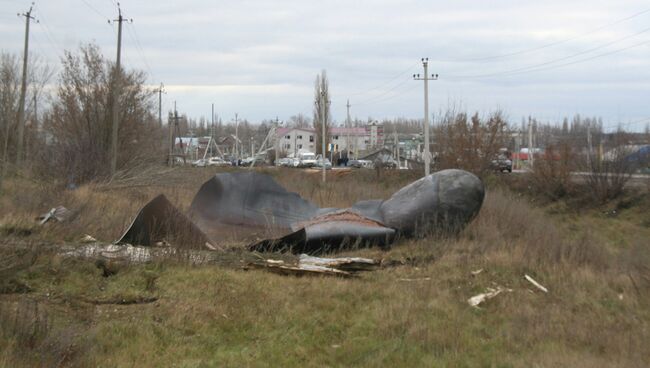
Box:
[0,0,650,130]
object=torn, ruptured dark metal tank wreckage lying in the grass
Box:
[120,170,485,254]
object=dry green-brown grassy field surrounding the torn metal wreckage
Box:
[0,169,650,367]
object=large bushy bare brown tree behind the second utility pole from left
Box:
[41,44,163,183]
